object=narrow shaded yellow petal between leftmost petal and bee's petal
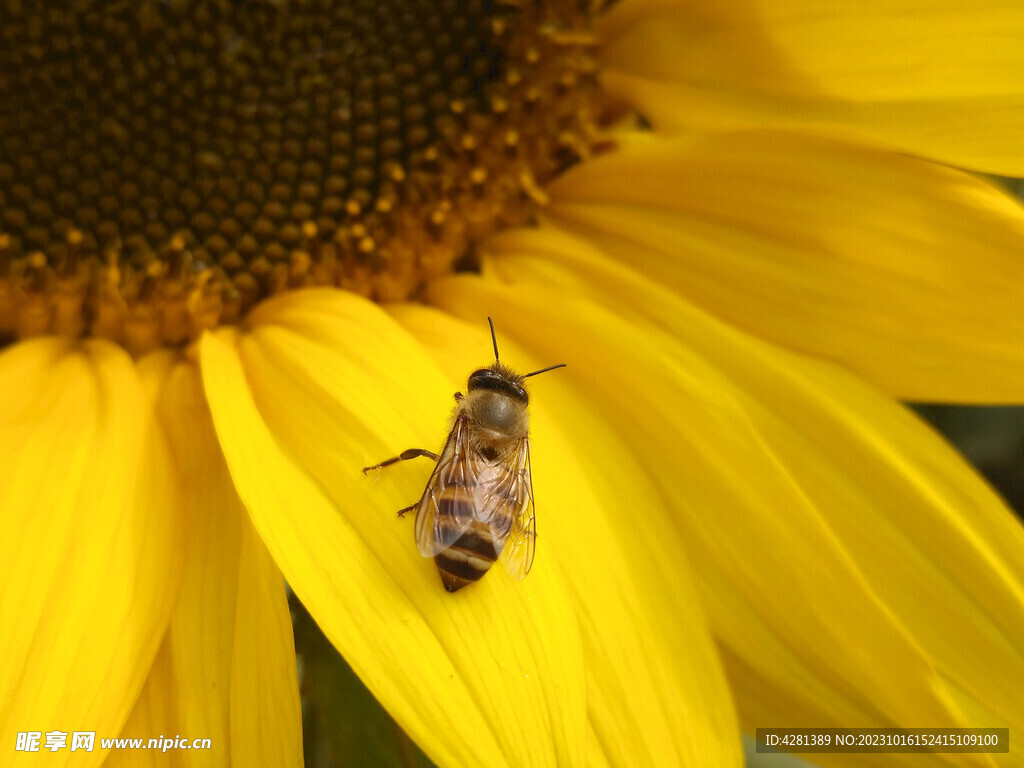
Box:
[141,354,302,766]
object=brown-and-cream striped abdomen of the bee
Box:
[434,485,515,592]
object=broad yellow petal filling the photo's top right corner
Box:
[601,0,1024,176]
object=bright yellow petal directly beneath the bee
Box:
[201,291,586,766]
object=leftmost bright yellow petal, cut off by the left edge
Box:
[0,339,181,765]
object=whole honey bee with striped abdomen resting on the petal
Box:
[362,317,565,592]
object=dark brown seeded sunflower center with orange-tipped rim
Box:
[0,0,599,353]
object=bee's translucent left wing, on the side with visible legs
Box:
[416,415,476,557]
